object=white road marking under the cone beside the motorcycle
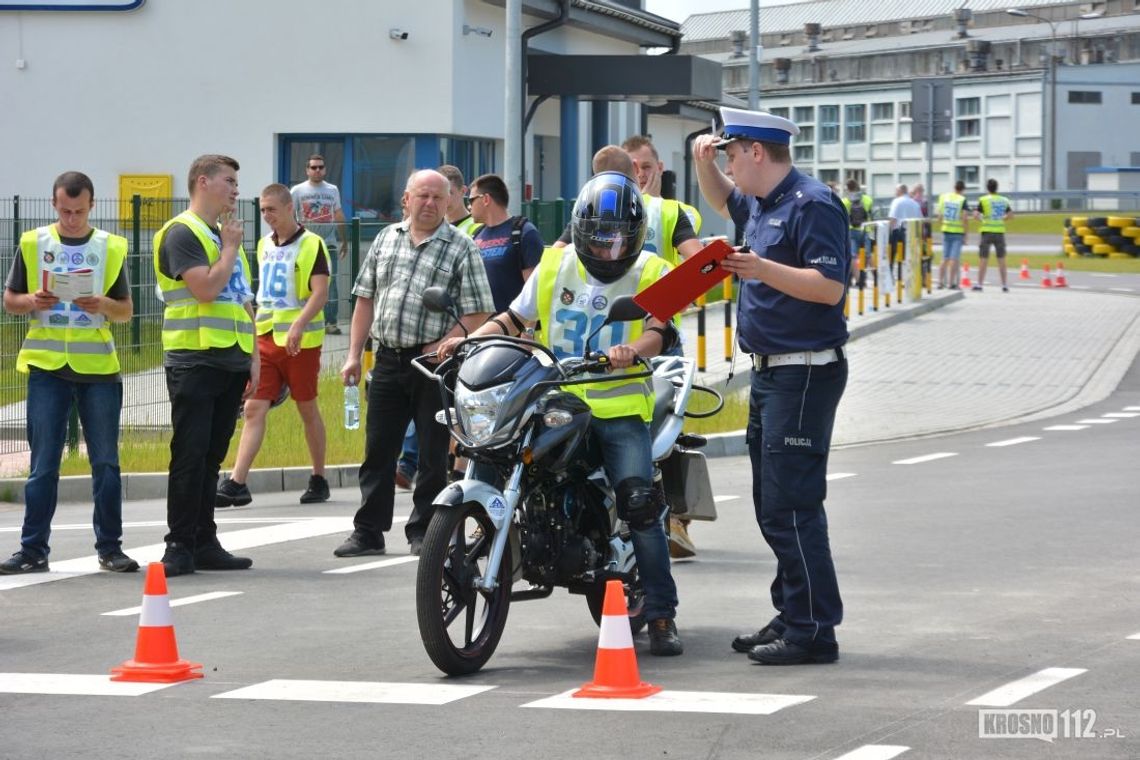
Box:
[522,689,815,716]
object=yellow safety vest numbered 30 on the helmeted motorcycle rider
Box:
[534,245,669,422]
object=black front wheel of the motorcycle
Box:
[416,504,511,676]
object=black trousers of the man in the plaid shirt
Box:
[353,349,449,541]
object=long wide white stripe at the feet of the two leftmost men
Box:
[0,516,360,591]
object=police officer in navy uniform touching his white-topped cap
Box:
[693,108,849,664]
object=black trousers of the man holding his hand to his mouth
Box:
[165,367,250,551]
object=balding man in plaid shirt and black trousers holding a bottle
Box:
[333,170,495,557]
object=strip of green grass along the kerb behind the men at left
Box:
[60,374,364,475]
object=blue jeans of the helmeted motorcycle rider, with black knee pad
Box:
[589,417,677,620]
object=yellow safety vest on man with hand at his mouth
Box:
[154,211,253,353]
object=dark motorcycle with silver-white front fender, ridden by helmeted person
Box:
[413,288,723,676]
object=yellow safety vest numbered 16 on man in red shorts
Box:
[257,230,332,349]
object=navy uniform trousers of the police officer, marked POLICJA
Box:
[746,360,847,646]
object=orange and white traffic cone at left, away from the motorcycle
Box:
[111,562,202,684]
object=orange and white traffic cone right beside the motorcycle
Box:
[573,580,661,700]
